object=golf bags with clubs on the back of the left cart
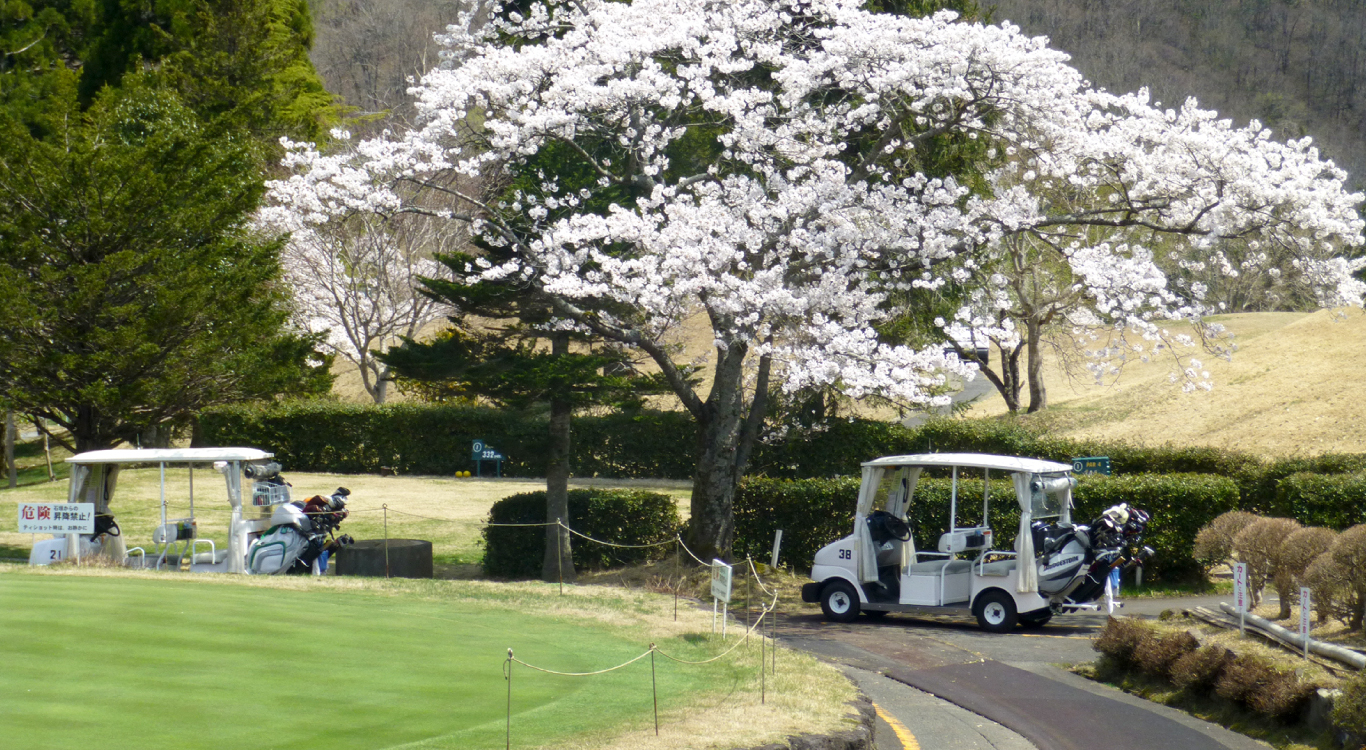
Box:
[247,486,354,575]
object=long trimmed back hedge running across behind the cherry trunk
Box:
[195,400,1366,538]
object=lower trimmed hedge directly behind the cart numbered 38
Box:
[735,474,1238,581]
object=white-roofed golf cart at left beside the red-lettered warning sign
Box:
[29,448,290,572]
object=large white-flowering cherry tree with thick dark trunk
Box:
[272,0,1362,555]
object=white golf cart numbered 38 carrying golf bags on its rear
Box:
[802,454,1152,633]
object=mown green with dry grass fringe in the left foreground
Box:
[0,566,854,750]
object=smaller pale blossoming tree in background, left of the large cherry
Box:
[257,195,467,403]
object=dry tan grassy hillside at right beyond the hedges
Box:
[968,310,1366,455]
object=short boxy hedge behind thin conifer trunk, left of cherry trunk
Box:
[482,489,682,578]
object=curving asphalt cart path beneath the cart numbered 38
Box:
[781,600,1269,750]
